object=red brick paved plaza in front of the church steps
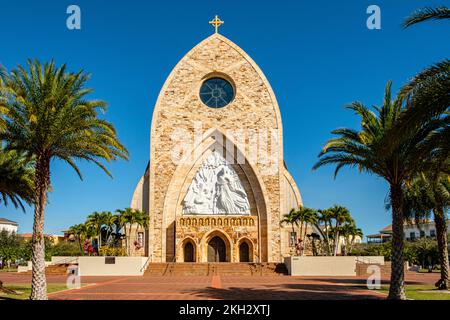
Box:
[0,274,439,300]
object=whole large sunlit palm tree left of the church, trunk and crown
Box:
[0,60,127,299]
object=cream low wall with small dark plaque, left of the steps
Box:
[78,257,147,276]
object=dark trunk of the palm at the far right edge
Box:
[434,206,449,290]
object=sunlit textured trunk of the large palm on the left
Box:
[30,155,50,300]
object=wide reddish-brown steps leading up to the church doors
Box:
[144,262,287,276]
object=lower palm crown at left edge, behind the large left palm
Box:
[0,148,34,210]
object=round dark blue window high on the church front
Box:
[200,78,234,108]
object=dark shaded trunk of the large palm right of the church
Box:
[388,184,406,300]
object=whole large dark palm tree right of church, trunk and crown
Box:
[313,81,442,299]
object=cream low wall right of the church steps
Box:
[284,256,384,276]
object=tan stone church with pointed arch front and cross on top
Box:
[131,17,302,262]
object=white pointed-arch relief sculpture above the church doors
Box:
[183,151,250,215]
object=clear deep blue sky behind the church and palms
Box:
[0,0,450,239]
